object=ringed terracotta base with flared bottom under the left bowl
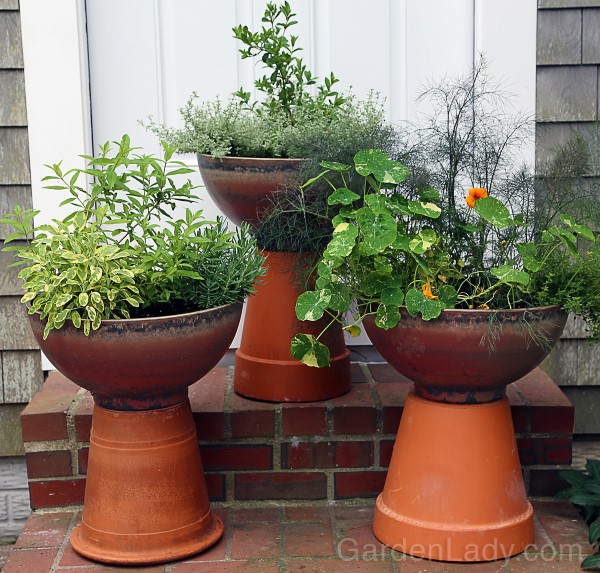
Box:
[71,400,223,565]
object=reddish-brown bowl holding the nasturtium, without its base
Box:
[365,306,567,403]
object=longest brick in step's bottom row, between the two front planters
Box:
[234,472,327,500]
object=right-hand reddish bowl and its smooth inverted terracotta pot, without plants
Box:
[365,307,566,562]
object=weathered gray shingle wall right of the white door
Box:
[536,0,600,428]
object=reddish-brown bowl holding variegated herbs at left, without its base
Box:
[30,304,242,410]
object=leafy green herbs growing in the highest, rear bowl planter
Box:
[144,1,349,157]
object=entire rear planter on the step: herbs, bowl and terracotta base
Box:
[149,2,393,402]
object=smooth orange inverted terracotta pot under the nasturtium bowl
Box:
[373,394,534,562]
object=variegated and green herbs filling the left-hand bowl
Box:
[0,135,263,337]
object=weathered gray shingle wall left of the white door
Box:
[0,0,43,452]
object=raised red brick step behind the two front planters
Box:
[21,363,573,509]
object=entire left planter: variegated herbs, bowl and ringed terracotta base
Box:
[2,135,263,564]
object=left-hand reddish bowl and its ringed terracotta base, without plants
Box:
[31,303,241,565]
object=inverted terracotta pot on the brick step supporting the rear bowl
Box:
[234,252,350,402]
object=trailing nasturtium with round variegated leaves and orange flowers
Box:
[291,150,600,366]
